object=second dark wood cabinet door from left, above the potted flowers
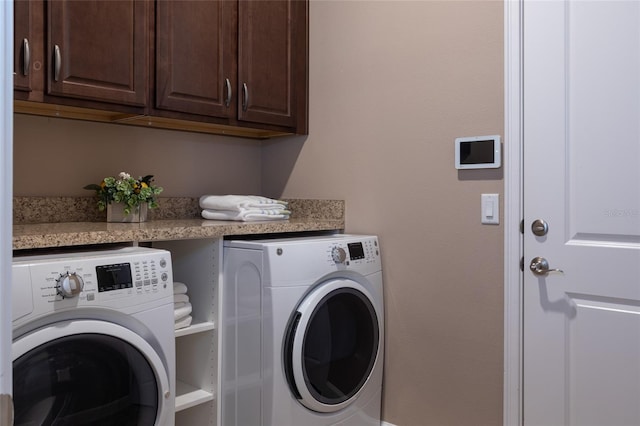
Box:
[47,0,149,106]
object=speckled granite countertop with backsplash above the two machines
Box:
[13,197,345,250]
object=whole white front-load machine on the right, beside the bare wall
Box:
[221,234,384,426]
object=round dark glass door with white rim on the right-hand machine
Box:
[284,279,381,413]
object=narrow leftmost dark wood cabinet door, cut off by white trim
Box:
[13,0,44,99]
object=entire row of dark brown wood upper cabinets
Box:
[12,0,309,138]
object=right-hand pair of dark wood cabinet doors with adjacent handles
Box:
[155,0,308,133]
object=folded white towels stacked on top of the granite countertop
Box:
[200,195,291,222]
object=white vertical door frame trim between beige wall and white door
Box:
[503,0,524,426]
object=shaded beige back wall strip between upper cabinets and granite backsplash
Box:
[14,114,262,197]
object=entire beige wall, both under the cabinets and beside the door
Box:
[14,0,503,426]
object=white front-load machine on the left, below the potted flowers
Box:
[12,247,175,426]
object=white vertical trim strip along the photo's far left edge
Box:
[0,1,13,402]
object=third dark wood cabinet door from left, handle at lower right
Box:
[155,0,237,118]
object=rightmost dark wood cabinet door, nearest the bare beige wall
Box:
[237,0,308,133]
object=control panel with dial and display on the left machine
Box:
[12,247,173,319]
